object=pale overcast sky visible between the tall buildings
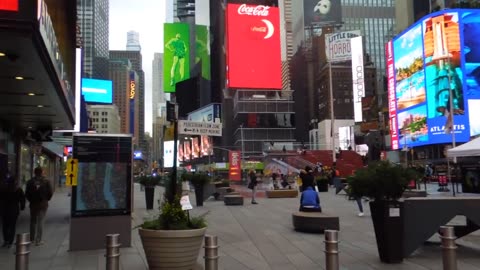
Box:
[110,0,165,134]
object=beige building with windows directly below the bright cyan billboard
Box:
[87,104,121,134]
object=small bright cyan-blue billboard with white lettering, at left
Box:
[82,78,113,104]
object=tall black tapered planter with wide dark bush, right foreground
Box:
[348,161,415,263]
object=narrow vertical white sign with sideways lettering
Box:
[350,36,365,122]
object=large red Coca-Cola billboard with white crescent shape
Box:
[227,4,282,89]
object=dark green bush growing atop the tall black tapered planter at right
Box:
[347,161,417,200]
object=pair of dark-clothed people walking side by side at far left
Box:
[0,167,53,248]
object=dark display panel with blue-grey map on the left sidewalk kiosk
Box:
[72,134,133,216]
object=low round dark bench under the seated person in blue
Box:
[292,212,340,233]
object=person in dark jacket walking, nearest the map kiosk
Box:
[25,167,53,246]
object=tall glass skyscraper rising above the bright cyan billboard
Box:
[77,0,109,79]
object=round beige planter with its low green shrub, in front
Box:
[139,192,207,270]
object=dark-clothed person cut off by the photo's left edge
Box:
[0,174,25,248]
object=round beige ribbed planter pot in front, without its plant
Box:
[138,228,207,270]
